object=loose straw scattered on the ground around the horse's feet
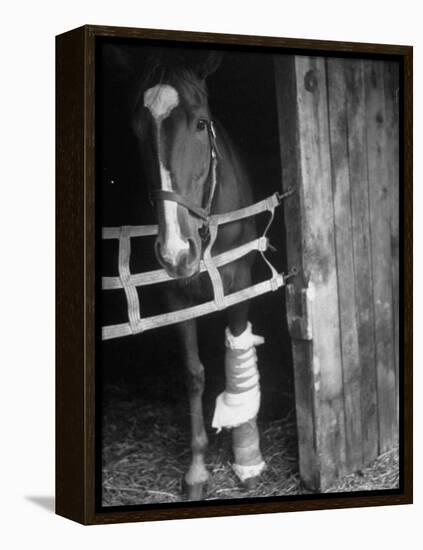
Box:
[103,387,398,506]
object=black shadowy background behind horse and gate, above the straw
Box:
[97,42,294,424]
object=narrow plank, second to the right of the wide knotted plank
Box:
[344,60,379,464]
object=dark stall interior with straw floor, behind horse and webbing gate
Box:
[99,52,300,505]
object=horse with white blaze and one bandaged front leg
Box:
[131,51,265,500]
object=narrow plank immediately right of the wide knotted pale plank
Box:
[326,58,363,471]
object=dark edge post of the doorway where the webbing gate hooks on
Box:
[274,55,320,490]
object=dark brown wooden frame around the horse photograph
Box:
[56,25,413,524]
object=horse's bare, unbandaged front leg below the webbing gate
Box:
[178,321,209,500]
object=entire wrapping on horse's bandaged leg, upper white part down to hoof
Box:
[212,323,265,481]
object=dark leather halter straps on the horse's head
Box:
[150,120,217,232]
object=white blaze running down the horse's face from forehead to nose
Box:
[144,84,189,263]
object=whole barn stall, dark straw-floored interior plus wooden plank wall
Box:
[97,46,399,505]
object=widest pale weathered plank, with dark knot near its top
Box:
[295,56,347,490]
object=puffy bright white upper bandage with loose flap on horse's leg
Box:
[212,323,264,431]
